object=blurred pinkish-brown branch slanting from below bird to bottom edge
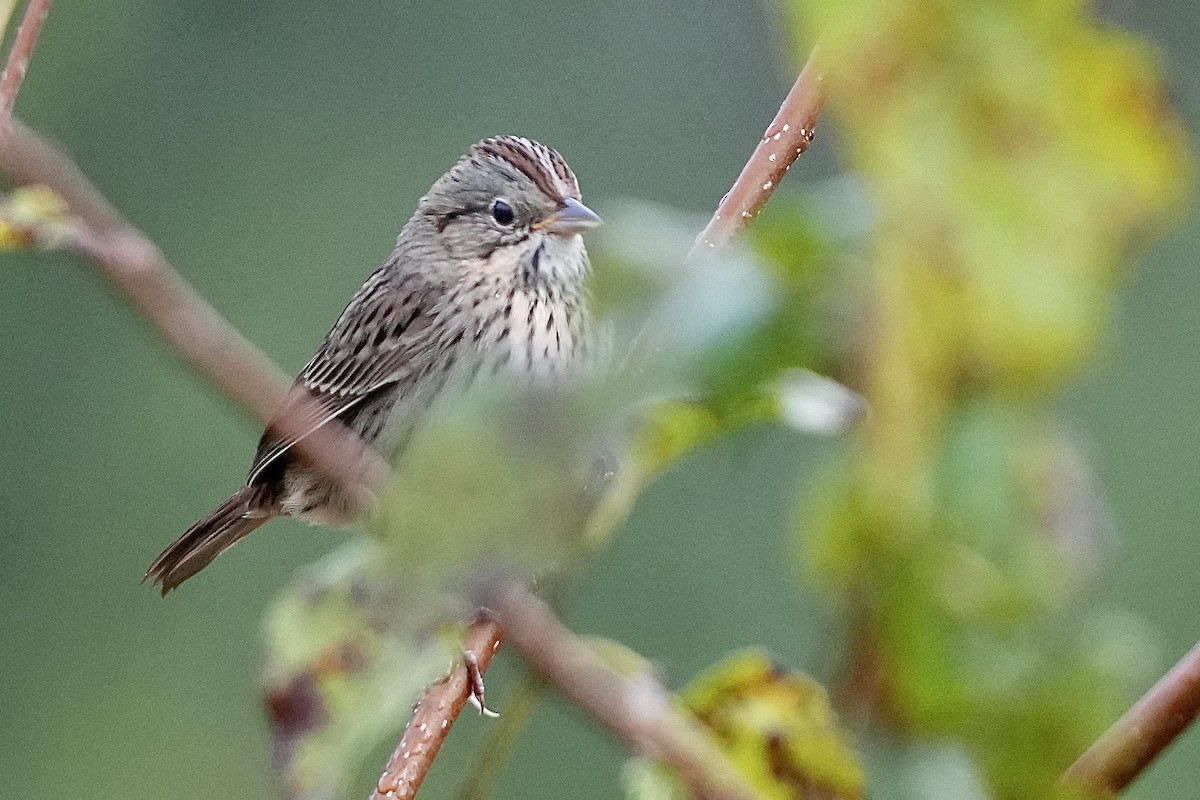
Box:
[481,582,756,800]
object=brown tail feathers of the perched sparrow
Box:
[145,486,274,595]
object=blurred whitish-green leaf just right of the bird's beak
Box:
[596,198,834,429]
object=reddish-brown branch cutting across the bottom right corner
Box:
[1063,644,1200,798]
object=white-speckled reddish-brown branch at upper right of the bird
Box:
[691,49,824,258]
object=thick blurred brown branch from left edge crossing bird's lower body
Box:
[0,120,388,505]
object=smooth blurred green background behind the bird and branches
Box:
[0,0,1200,800]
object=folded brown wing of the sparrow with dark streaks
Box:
[246,269,434,483]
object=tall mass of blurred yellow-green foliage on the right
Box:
[777,0,1192,798]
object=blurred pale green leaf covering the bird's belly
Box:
[371,383,620,609]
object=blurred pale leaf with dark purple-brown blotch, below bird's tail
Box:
[265,541,451,800]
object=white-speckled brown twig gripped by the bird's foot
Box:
[371,620,502,800]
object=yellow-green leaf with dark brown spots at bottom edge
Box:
[625,651,866,800]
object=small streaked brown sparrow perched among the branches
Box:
[145,136,601,595]
